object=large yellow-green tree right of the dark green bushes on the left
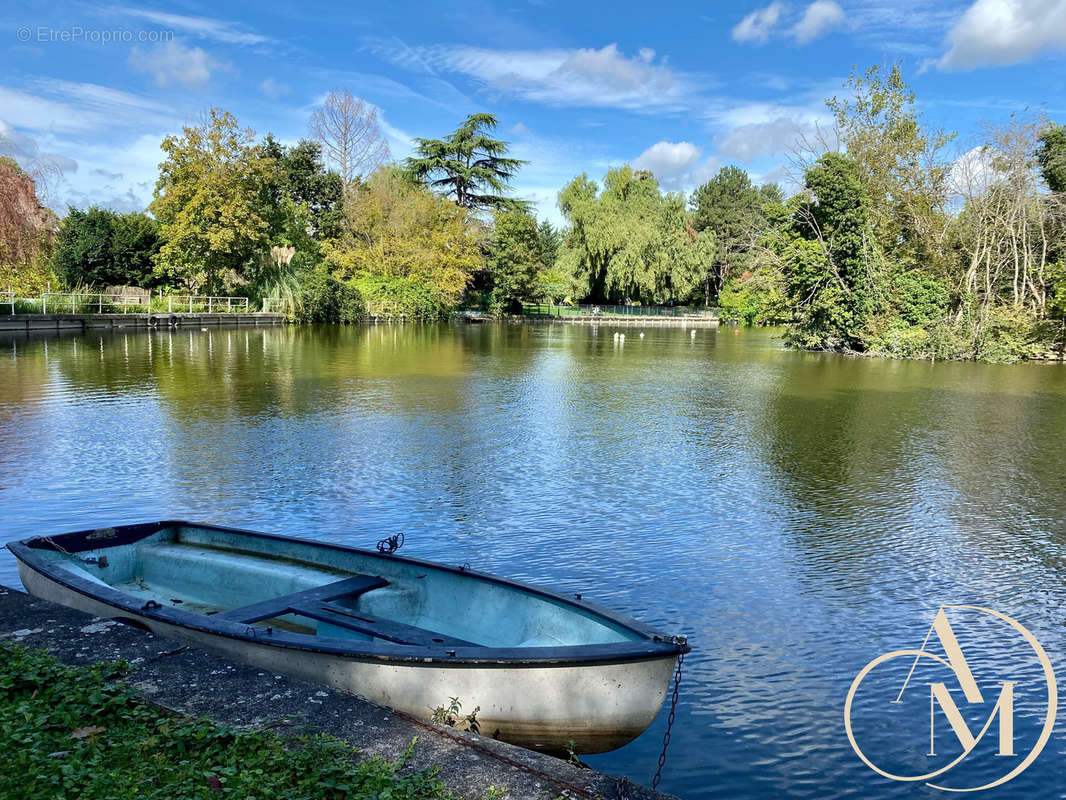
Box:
[149,109,275,292]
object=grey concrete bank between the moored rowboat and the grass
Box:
[0,587,669,800]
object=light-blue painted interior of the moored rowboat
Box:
[42,526,644,647]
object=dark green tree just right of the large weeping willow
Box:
[692,166,779,305]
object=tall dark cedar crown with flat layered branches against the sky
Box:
[404,114,526,209]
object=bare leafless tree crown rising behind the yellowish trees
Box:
[310,89,391,186]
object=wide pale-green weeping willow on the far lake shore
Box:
[559,166,714,304]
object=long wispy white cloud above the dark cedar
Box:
[368,39,687,110]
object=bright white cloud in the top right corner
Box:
[938,0,1066,69]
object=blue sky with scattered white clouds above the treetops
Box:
[0,0,1066,222]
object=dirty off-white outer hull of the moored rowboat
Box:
[18,560,675,753]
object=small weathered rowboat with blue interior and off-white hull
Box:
[7,521,689,753]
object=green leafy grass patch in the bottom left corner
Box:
[0,644,452,800]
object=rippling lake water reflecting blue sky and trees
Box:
[0,324,1066,798]
